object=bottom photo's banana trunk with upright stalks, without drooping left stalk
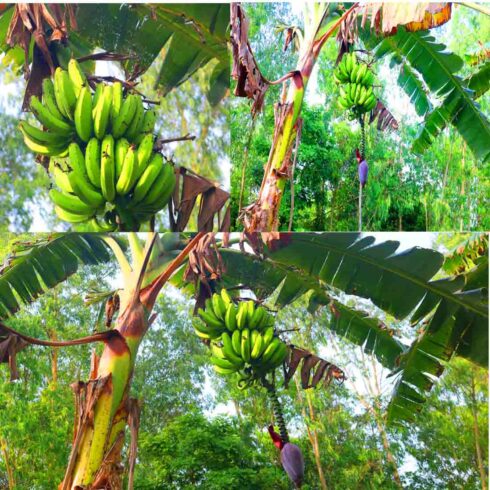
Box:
[59,233,203,490]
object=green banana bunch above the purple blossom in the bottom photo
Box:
[194,289,288,379]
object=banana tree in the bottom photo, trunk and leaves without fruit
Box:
[0,233,488,489]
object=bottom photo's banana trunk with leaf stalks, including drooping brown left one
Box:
[0,232,205,490]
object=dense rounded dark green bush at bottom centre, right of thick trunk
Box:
[135,413,288,490]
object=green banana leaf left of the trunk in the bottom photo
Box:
[0,233,112,318]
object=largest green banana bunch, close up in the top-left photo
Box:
[19,59,175,231]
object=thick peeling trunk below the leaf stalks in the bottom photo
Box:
[62,296,143,489]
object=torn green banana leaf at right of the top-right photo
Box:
[368,27,490,161]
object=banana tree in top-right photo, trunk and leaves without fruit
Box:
[232,2,490,232]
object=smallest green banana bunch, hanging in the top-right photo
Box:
[334,53,376,115]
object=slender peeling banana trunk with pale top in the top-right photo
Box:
[243,3,357,233]
